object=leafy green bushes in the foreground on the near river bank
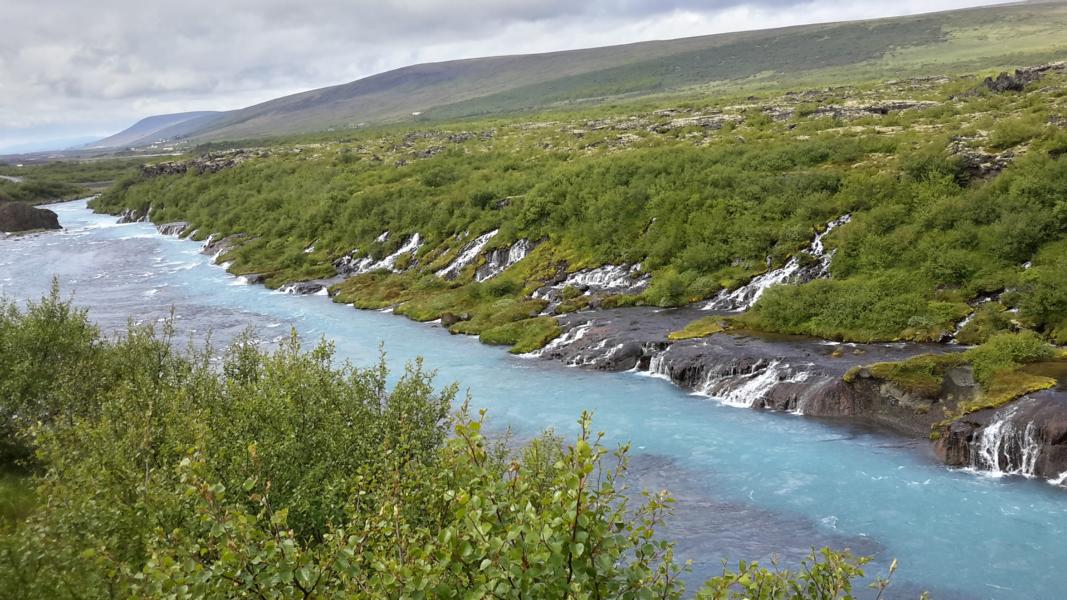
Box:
[0,289,888,600]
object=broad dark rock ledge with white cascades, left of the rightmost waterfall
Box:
[540,307,960,437]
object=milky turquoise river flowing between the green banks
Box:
[0,201,1067,599]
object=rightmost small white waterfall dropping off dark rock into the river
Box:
[971,406,1041,477]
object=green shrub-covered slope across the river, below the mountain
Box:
[93,67,1067,350]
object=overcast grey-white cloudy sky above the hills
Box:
[0,0,997,152]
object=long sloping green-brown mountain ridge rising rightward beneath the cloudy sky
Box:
[99,1,1067,145]
